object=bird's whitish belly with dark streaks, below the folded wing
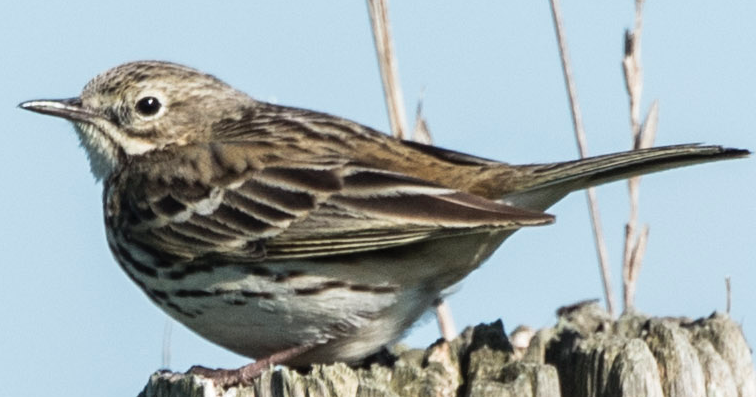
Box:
[109,227,506,365]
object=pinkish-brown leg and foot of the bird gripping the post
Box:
[186,345,313,387]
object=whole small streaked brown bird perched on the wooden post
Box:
[20,61,749,383]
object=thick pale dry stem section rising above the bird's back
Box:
[367,0,407,139]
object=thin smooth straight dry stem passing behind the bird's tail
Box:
[551,0,615,316]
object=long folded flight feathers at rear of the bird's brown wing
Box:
[266,167,553,259]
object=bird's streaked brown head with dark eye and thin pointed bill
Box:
[19,61,253,180]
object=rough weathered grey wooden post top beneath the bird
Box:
[140,303,756,397]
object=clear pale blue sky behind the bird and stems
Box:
[0,0,756,396]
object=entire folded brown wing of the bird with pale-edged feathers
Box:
[115,142,553,262]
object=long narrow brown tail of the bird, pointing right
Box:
[501,144,751,210]
